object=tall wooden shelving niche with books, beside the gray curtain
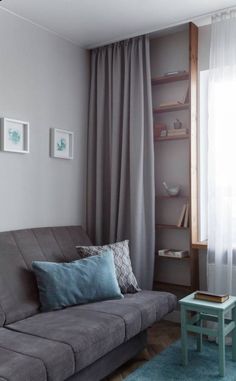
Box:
[151,23,199,297]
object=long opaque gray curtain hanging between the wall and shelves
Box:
[87,36,155,289]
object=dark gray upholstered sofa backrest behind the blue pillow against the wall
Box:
[0,226,91,326]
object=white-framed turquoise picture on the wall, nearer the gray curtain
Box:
[51,128,74,160]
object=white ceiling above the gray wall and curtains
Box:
[1,0,236,48]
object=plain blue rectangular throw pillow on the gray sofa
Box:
[32,250,123,311]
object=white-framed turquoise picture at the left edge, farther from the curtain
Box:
[1,118,29,153]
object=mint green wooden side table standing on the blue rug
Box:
[179,292,236,377]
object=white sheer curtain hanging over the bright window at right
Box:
[208,11,236,295]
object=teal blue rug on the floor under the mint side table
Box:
[125,337,236,381]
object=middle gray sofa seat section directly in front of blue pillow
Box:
[7,306,125,371]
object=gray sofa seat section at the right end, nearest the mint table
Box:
[78,291,177,334]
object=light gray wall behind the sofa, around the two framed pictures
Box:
[0,10,89,231]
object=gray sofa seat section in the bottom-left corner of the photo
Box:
[0,347,47,381]
